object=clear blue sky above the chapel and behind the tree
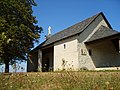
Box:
[0,0,120,72]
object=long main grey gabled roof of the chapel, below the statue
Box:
[34,12,112,51]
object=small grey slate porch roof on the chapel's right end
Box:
[86,25,119,42]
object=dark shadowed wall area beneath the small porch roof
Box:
[86,40,120,68]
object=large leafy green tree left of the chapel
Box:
[0,0,42,72]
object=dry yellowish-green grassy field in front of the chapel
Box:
[0,71,120,90]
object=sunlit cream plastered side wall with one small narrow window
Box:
[54,36,78,71]
